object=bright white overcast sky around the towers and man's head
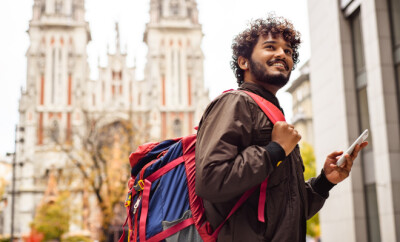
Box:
[0,0,310,157]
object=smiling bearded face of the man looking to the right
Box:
[245,34,293,93]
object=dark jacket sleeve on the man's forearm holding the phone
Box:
[306,170,335,219]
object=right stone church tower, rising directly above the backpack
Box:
[144,0,208,138]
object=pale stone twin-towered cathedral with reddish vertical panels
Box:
[4,0,209,237]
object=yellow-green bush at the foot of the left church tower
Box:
[31,192,70,241]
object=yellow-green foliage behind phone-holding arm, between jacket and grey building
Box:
[300,142,321,238]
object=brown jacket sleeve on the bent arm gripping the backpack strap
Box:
[196,93,273,202]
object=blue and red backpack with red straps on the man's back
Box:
[119,90,285,242]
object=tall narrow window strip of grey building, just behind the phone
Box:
[349,9,381,242]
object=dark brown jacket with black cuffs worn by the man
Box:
[196,83,332,242]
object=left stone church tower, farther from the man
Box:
[4,0,91,235]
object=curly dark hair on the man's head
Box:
[231,14,301,86]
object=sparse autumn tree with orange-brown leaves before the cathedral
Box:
[50,112,146,241]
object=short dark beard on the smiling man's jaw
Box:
[249,58,291,88]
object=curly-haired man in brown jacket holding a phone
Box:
[196,16,367,242]
